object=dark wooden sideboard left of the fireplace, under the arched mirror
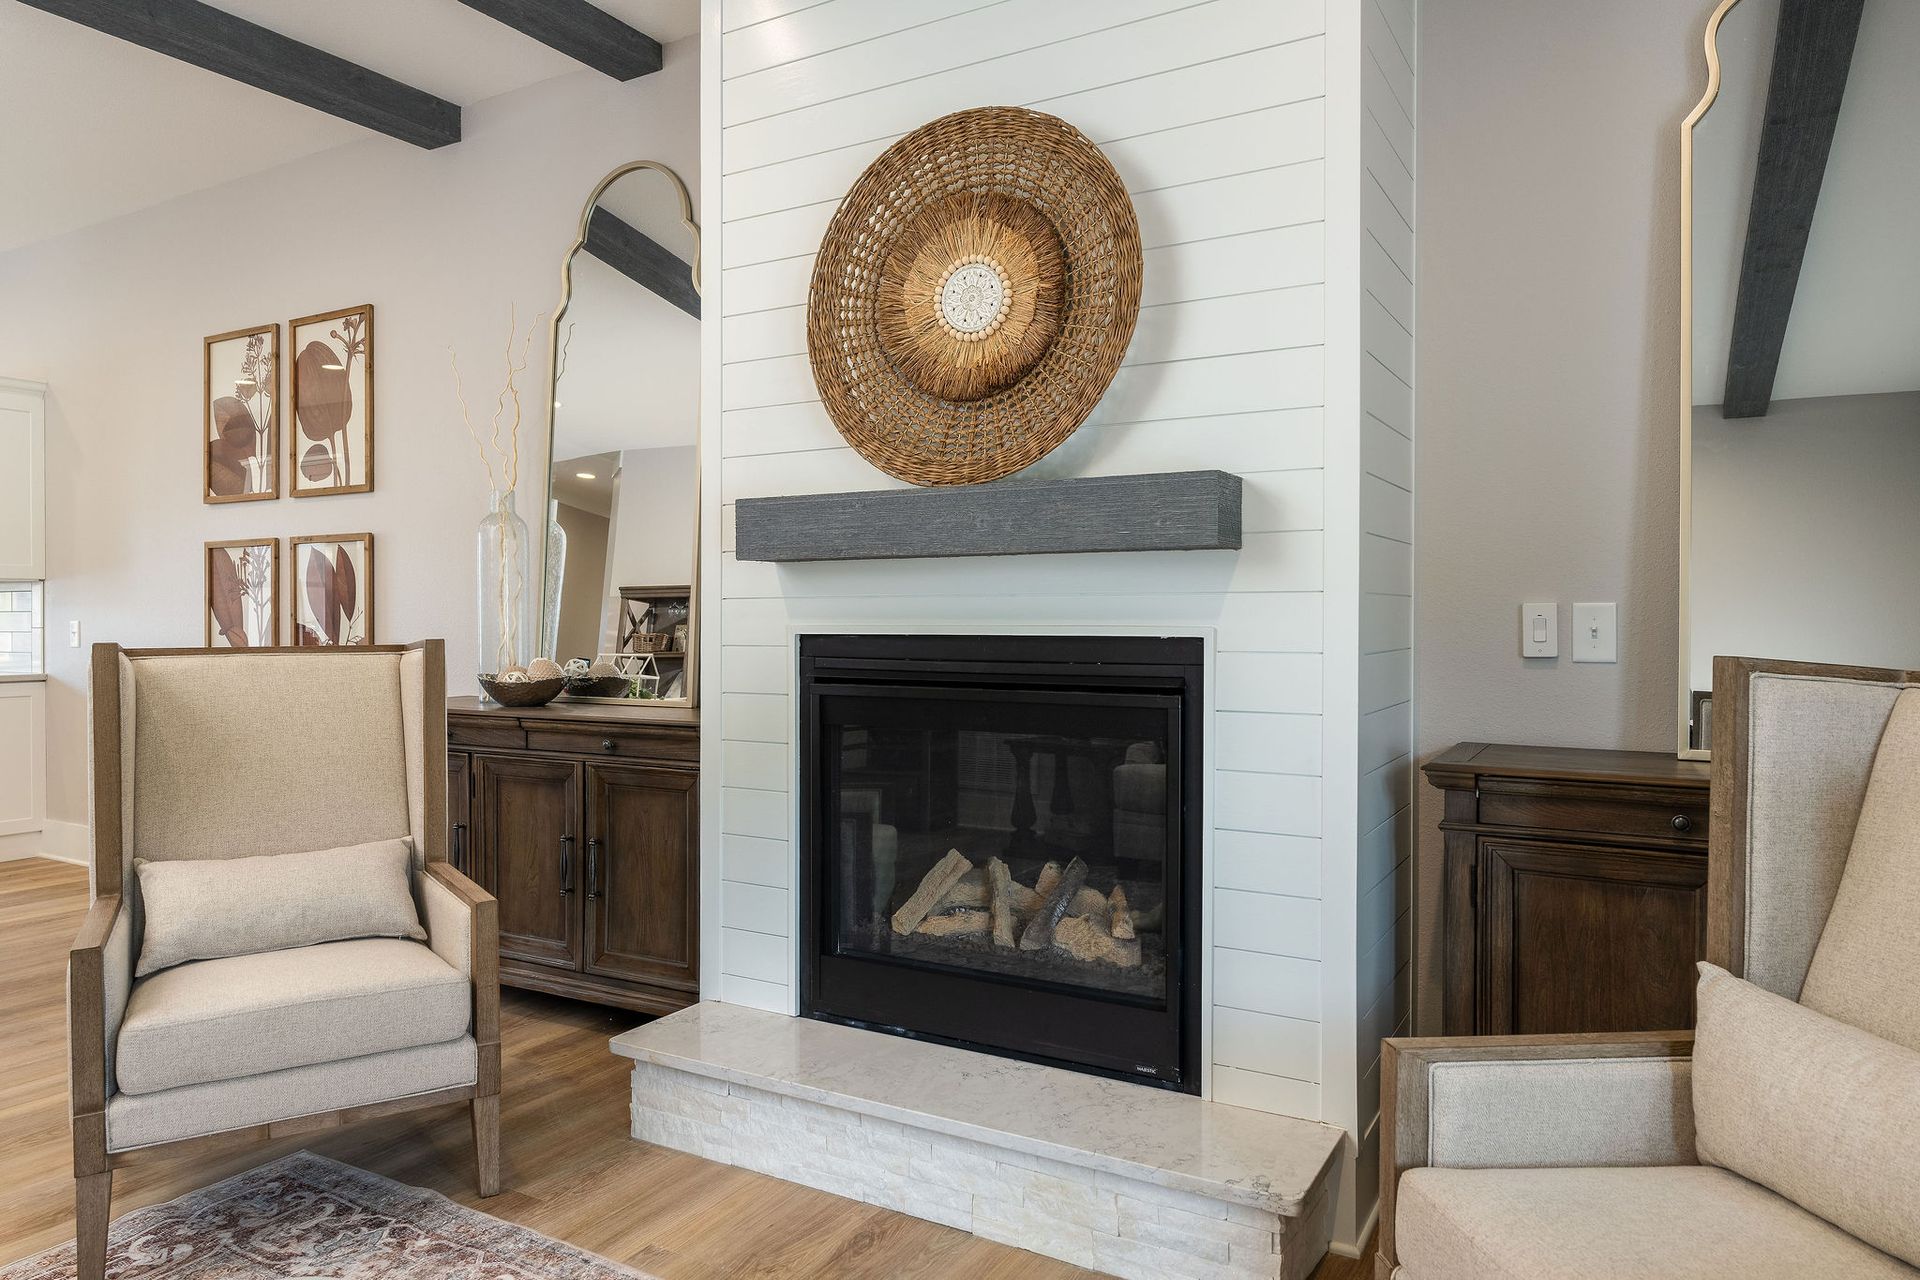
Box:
[447,699,701,1013]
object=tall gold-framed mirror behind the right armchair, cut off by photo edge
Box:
[1680,0,1920,754]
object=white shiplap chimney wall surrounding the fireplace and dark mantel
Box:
[705,0,1411,1251]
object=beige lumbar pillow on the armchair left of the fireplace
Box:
[132,839,426,977]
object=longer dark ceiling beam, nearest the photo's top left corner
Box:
[25,0,461,148]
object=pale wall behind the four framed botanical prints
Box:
[0,40,699,823]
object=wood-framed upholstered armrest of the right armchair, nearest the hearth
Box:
[1380,1031,1695,1276]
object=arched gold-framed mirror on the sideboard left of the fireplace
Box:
[541,161,701,706]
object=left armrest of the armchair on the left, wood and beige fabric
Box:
[67,894,132,1173]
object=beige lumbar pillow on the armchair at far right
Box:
[1693,963,1920,1267]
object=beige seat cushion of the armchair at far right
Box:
[1394,1165,1920,1280]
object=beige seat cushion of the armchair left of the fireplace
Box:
[115,938,472,1094]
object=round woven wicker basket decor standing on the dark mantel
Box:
[806,107,1140,486]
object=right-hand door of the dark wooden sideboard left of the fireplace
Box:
[586,764,701,992]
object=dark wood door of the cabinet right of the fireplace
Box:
[1480,841,1707,1036]
